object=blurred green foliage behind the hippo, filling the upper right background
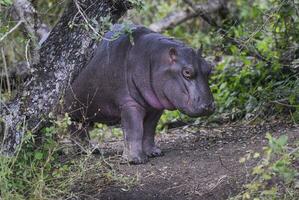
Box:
[132,0,299,123]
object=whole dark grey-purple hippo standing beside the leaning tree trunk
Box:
[64,24,215,164]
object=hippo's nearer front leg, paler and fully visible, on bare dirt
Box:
[121,105,148,164]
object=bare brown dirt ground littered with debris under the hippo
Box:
[68,122,299,200]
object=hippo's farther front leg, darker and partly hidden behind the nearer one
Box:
[143,111,163,157]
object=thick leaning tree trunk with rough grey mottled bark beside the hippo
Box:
[0,0,132,155]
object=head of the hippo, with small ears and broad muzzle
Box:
[152,47,215,117]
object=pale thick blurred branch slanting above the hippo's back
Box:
[149,0,224,32]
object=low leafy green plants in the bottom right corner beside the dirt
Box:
[233,133,299,200]
